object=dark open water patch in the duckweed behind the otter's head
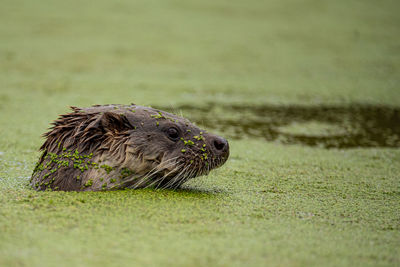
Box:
[158,103,400,148]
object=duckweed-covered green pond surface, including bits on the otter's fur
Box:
[0,0,400,267]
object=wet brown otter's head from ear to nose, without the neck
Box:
[78,105,229,191]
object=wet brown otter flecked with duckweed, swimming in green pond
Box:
[30,104,229,191]
